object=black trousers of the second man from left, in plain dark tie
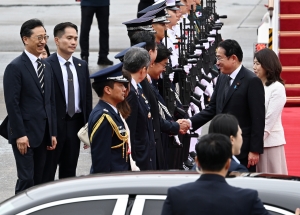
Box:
[43,113,84,182]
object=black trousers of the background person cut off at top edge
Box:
[79,6,109,57]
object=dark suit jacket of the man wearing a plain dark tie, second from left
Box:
[46,53,92,128]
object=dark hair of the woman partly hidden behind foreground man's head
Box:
[208,114,239,137]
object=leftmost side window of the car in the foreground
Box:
[30,199,117,215]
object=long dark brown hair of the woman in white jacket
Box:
[254,48,284,86]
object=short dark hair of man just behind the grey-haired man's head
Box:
[130,31,156,51]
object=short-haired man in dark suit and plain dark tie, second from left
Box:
[44,22,92,182]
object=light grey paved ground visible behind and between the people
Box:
[0,0,267,202]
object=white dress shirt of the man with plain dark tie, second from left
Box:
[57,54,81,113]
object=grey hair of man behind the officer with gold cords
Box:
[123,47,150,73]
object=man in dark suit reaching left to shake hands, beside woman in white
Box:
[190,40,265,172]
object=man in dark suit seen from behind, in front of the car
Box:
[161,134,269,215]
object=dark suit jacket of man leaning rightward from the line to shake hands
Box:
[141,78,179,169]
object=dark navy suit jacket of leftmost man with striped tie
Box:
[3,52,57,148]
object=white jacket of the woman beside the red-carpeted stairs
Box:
[264,81,286,147]
